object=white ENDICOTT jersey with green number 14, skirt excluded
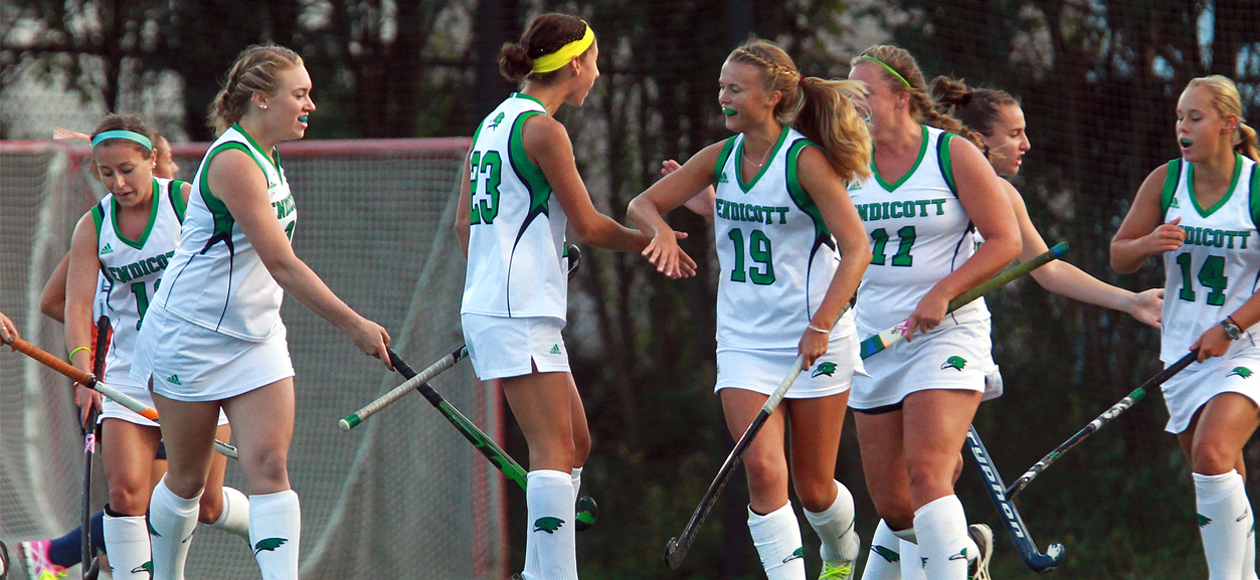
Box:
[1159,155,1260,363]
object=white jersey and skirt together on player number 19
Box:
[713,127,862,398]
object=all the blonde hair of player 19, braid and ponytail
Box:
[727,39,871,182]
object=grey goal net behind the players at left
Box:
[0,139,508,579]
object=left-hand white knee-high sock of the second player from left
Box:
[149,478,202,580]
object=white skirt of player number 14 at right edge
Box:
[1163,340,1260,434]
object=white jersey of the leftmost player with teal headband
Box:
[92,178,184,385]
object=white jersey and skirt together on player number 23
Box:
[460,93,568,381]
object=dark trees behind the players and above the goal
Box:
[0,0,1260,579]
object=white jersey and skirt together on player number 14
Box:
[1159,155,1260,432]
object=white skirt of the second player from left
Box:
[131,303,294,401]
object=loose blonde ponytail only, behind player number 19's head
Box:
[791,77,871,182]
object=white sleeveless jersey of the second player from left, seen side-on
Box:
[156,125,297,342]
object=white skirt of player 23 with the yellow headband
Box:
[460,314,570,381]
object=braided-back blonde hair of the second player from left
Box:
[208,44,302,134]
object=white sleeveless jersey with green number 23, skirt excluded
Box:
[460,93,568,319]
